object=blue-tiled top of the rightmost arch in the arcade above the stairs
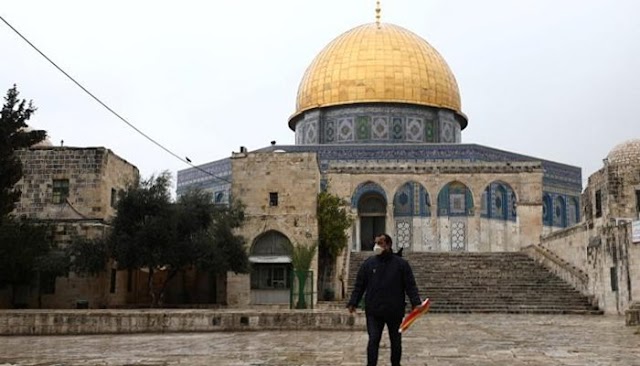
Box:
[481,181,518,221]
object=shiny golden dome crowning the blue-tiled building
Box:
[289,23,466,129]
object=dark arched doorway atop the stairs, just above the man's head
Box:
[358,192,387,251]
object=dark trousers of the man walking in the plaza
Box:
[367,314,402,366]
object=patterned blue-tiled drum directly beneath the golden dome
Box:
[295,103,462,145]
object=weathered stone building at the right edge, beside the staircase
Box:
[540,139,640,314]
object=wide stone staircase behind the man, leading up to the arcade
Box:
[348,252,603,314]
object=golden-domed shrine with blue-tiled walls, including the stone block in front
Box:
[177,22,582,305]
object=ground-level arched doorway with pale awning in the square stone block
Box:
[249,230,291,304]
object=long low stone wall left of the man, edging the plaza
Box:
[0,310,365,336]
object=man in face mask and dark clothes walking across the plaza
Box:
[347,234,421,366]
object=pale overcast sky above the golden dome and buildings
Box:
[0,0,640,189]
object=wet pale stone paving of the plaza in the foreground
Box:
[0,314,640,366]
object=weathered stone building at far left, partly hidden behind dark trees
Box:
[0,146,139,308]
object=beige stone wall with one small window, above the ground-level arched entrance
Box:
[227,152,320,306]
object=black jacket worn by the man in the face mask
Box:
[347,252,421,317]
